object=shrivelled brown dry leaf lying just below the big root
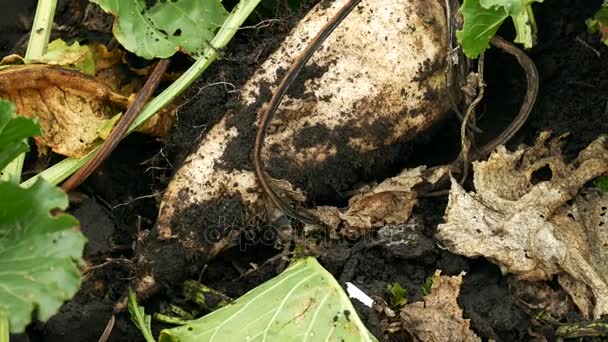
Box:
[312,166,449,238]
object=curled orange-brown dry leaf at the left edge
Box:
[0,65,127,157]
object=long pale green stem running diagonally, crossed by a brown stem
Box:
[23,0,260,186]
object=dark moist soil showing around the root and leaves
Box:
[0,0,608,341]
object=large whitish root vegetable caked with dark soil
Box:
[146,0,449,284]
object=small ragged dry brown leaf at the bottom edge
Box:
[400,270,481,342]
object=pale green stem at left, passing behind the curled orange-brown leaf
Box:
[2,0,57,181]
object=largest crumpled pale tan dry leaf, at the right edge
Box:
[437,133,608,318]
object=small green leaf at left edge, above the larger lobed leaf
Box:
[0,99,41,175]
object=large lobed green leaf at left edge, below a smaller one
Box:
[0,180,85,333]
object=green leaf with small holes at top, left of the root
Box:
[91,0,228,59]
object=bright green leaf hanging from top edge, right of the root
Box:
[456,0,543,58]
